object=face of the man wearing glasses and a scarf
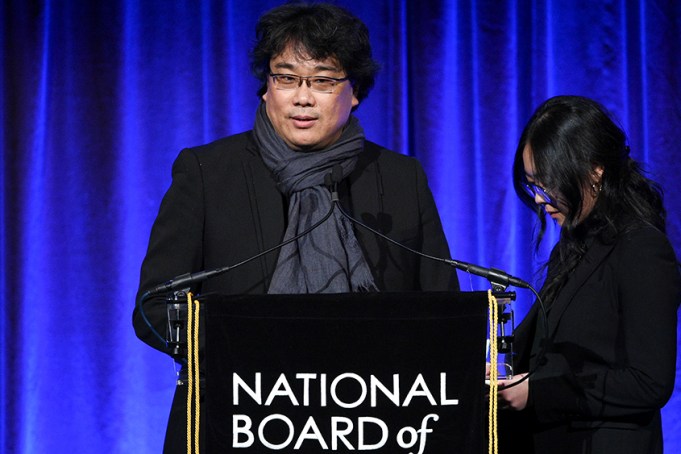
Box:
[262,46,359,151]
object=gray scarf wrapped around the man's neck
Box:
[253,103,376,294]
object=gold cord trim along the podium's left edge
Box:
[187,292,201,454]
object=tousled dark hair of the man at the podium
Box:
[251,3,378,102]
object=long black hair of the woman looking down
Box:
[513,96,666,304]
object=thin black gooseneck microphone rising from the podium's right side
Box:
[327,164,532,289]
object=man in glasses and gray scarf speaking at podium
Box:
[133,4,458,452]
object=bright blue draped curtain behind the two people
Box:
[0,0,681,453]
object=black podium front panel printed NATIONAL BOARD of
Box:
[191,292,487,454]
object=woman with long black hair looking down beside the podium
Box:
[498,96,681,453]
